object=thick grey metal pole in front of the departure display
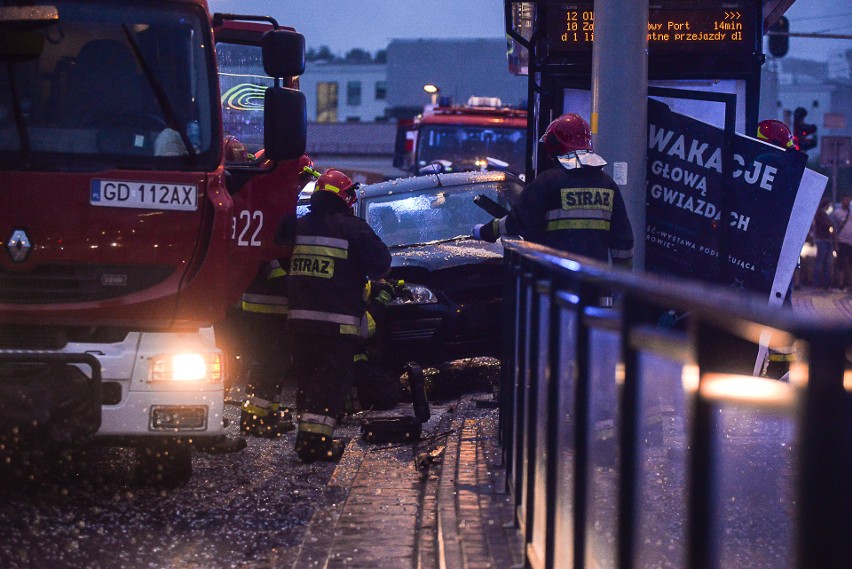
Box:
[589,0,648,270]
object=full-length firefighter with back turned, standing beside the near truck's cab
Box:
[278,169,391,463]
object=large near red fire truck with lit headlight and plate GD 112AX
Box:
[0,0,306,483]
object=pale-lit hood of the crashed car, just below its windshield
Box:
[390,239,503,271]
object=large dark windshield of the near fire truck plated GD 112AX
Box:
[0,0,216,171]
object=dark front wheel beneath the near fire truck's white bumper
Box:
[136,439,192,488]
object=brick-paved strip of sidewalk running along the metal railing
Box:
[293,394,522,569]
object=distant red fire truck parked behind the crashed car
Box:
[394,97,527,174]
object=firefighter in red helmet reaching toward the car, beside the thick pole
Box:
[473,113,633,268]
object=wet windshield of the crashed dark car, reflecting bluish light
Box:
[363,182,514,247]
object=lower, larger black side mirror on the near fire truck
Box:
[263,87,308,160]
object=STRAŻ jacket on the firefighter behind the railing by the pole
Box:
[480,166,633,266]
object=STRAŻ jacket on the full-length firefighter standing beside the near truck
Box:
[287,192,391,336]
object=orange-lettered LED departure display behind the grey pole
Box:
[547,2,760,54]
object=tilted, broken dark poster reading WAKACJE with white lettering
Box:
[646,99,825,304]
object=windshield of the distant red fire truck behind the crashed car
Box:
[417,125,526,174]
